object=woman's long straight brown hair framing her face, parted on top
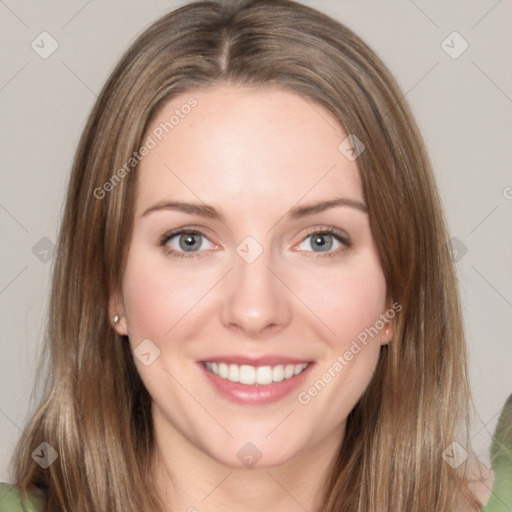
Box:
[13,0,479,512]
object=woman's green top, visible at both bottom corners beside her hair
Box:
[0,395,512,512]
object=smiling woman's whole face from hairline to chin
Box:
[111,85,394,467]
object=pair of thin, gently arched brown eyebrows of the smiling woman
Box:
[142,197,368,222]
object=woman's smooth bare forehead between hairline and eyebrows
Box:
[136,84,363,215]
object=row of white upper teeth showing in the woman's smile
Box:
[205,361,308,386]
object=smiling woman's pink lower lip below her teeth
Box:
[199,363,314,405]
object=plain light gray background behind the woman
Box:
[0,0,512,481]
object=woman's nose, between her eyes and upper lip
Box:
[221,245,292,338]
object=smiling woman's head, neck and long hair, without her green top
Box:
[0,0,506,512]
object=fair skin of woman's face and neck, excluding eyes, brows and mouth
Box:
[110,84,393,512]
